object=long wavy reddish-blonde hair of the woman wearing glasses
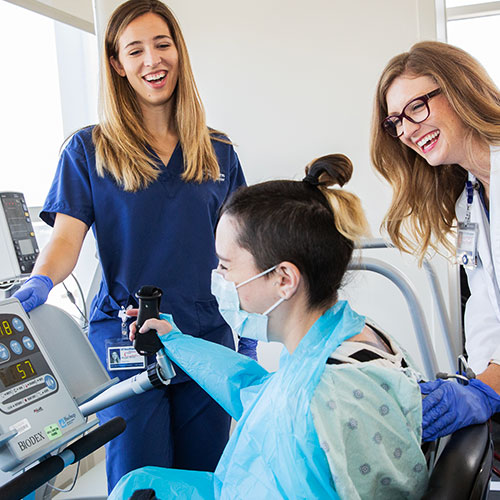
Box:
[370,42,500,264]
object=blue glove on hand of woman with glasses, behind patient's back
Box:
[420,379,500,441]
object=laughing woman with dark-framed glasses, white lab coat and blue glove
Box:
[371,42,500,440]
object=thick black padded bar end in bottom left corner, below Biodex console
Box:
[0,455,64,500]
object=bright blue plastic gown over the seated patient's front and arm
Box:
[109,302,426,500]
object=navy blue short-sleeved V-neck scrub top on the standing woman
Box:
[40,127,245,376]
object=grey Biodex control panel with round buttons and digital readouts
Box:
[0,298,87,471]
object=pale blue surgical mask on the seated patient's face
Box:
[212,266,285,342]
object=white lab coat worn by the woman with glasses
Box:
[456,147,500,373]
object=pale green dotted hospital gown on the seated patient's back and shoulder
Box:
[311,330,428,500]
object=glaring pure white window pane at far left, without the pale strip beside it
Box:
[0,2,63,205]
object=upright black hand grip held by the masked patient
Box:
[134,285,163,356]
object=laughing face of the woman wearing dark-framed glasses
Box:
[386,75,468,166]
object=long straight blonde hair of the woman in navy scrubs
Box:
[92,0,223,192]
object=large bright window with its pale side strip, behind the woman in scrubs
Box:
[0,1,97,206]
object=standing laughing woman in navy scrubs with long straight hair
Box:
[16,0,256,489]
